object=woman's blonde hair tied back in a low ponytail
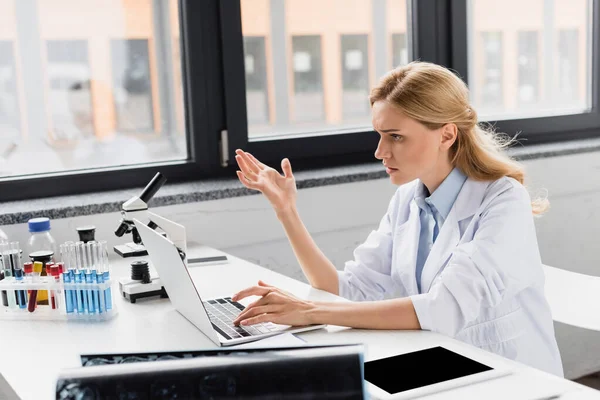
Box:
[369,61,549,215]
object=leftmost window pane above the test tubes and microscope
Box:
[0,0,188,179]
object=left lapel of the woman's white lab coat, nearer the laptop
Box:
[393,200,421,296]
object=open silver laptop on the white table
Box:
[133,219,325,346]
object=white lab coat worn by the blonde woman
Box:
[338,177,563,376]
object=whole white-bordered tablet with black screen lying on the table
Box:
[365,346,510,399]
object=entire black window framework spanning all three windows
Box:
[0,0,600,202]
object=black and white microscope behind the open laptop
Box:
[114,172,187,303]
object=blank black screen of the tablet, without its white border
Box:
[365,347,492,394]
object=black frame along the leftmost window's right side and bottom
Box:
[0,0,225,202]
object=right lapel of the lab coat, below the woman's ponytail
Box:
[421,179,490,293]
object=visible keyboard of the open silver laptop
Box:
[203,297,281,339]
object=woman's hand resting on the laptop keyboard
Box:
[231,281,315,326]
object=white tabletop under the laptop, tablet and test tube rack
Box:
[0,248,600,400]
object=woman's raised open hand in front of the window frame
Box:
[235,150,297,214]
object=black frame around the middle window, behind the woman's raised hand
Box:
[220,0,434,169]
